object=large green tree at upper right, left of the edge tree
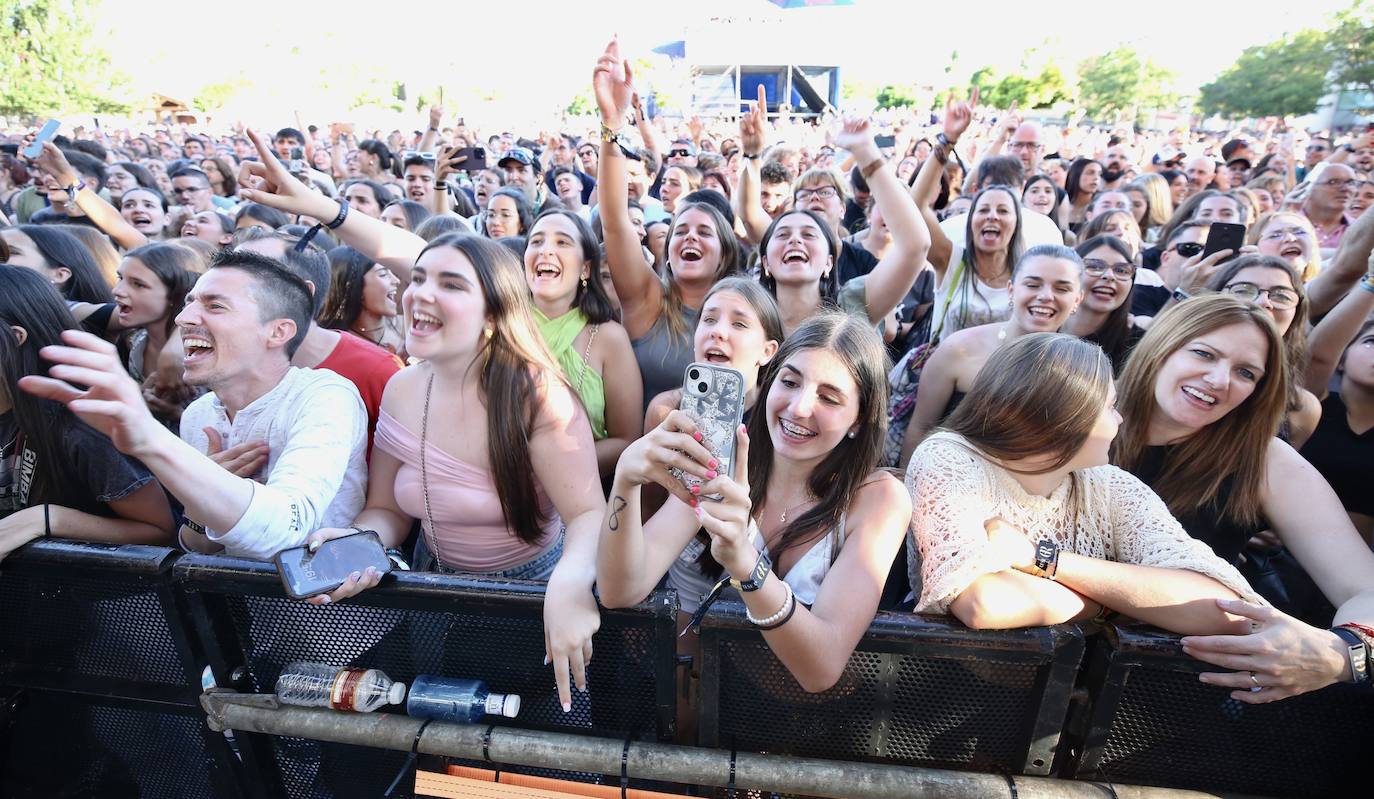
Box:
[1198,30,1331,117]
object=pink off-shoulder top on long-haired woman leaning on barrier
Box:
[374,410,562,572]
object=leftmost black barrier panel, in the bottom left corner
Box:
[0,541,245,799]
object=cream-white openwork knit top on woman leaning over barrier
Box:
[907,432,1267,614]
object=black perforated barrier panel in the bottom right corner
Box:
[1062,626,1374,796]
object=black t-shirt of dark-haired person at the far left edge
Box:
[0,412,153,518]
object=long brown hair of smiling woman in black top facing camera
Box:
[1112,294,1289,524]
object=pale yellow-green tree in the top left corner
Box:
[0,0,129,117]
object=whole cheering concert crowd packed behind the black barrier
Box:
[0,36,1374,708]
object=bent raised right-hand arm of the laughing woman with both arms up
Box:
[835,119,930,324]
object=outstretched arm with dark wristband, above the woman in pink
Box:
[239,130,426,284]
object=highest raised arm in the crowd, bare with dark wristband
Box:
[592,40,664,339]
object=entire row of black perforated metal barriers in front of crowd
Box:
[0,541,1374,799]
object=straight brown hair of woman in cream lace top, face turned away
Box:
[941,332,1112,475]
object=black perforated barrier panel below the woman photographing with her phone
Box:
[701,603,1084,774]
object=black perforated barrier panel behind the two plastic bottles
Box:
[174,555,677,796]
